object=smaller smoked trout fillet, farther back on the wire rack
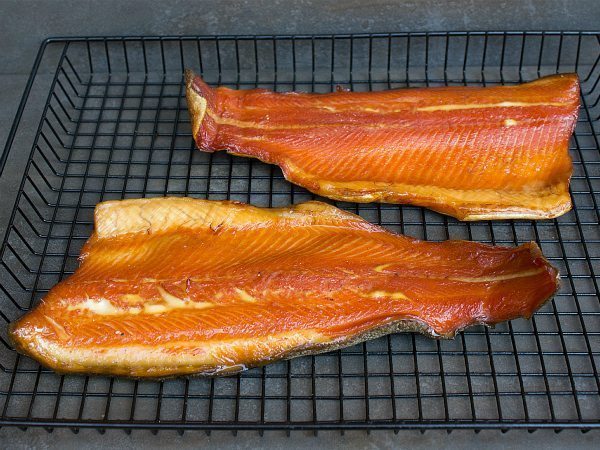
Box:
[186,70,579,220]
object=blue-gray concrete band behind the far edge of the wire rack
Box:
[0,0,600,73]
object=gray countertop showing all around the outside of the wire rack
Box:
[0,0,600,450]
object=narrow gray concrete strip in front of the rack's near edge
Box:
[0,429,598,450]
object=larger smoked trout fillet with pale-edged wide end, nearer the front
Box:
[10,198,559,377]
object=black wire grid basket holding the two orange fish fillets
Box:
[0,32,600,432]
